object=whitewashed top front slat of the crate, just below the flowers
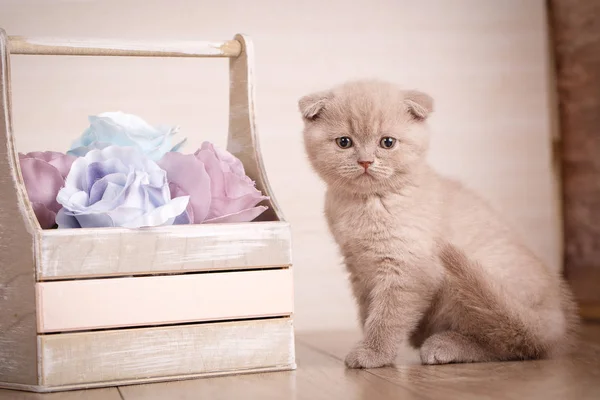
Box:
[37,222,292,280]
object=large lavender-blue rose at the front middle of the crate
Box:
[56,146,189,229]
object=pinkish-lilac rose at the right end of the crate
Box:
[159,142,268,224]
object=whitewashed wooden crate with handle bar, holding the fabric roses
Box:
[0,30,295,392]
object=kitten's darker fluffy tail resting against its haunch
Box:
[440,244,566,360]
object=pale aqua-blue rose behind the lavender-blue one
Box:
[67,111,186,161]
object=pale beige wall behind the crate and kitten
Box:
[0,0,561,330]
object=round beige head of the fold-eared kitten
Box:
[298,81,433,193]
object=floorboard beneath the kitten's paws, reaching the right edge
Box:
[298,325,600,400]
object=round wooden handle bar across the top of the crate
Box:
[9,36,241,57]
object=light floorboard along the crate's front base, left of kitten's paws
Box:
[120,343,412,400]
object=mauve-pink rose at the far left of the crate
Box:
[19,151,76,229]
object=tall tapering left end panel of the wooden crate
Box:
[0,29,37,385]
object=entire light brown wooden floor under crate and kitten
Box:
[0,325,600,400]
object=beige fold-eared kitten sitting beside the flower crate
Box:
[298,81,578,368]
